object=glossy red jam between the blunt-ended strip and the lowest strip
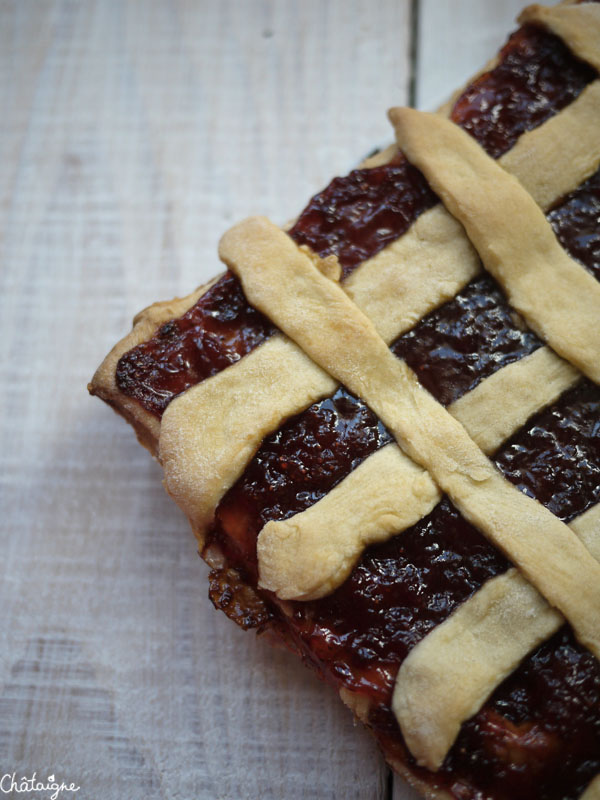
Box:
[284,499,508,703]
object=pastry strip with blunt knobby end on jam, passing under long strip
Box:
[257,347,580,600]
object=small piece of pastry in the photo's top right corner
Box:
[517,3,600,71]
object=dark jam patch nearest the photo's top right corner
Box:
[451,25,596,158]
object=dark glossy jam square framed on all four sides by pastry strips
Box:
[391,275,541,405]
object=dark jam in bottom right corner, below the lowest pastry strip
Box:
[440,627,600,800]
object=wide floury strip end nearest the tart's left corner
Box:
[160,334,336,539]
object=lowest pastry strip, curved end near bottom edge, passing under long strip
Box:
[392,504,600,770]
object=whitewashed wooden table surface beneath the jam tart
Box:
[0,0,520,800]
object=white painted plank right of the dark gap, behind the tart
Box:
[393,6,524,800]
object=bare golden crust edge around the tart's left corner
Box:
[88,273,223,458]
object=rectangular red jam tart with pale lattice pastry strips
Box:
[92,3,600,798]
